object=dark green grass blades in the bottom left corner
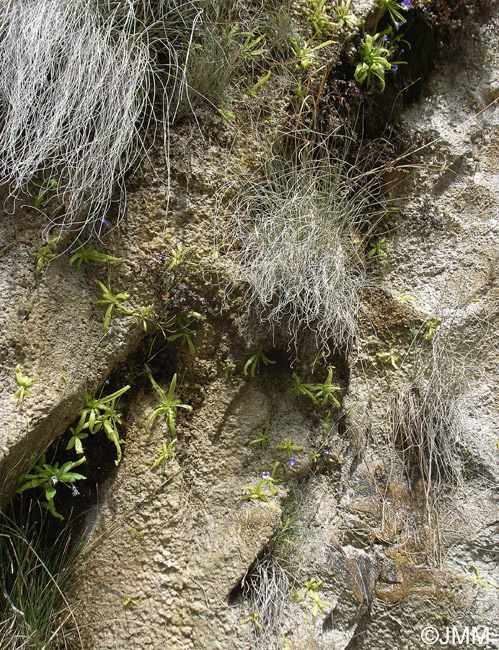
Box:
[0,502,81,650]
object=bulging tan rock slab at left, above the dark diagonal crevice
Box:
[0,175,166,500]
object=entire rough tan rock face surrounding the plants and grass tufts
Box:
[0,3,499,650]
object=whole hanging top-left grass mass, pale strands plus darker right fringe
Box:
[0,0,203,234]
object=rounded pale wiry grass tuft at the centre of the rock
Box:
[223,139,388,352]
